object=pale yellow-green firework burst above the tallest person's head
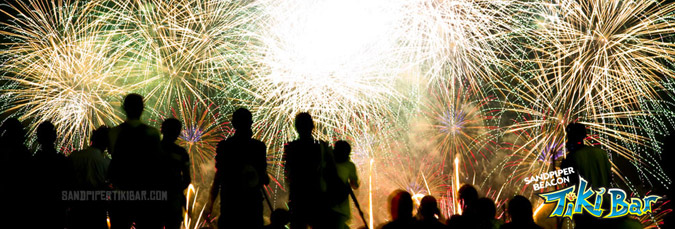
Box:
[103,0,256,111]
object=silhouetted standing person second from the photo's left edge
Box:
[33,121,71,228]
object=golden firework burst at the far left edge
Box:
[0,1,130,148]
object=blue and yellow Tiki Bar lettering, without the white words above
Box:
[539,177,661,219]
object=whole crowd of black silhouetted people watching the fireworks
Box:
[0,94,664,229]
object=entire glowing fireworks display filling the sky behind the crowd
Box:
[0,0,675,226]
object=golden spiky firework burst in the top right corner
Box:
[531,0,675,109]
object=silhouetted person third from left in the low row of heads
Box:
[448,184,478,228]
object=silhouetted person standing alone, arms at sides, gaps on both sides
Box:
[207,108,269,228]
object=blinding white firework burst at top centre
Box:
[245,0,511,150]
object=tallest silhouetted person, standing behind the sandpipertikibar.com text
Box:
[108,94,163,229]
